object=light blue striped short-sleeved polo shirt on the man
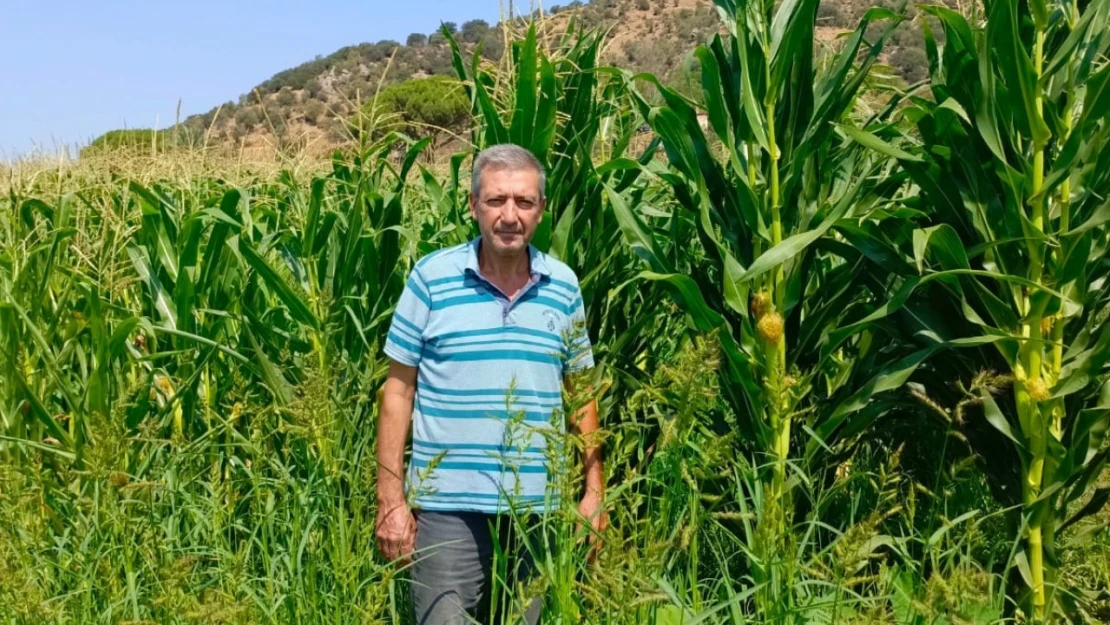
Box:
[385,238,594,513]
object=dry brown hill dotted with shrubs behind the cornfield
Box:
[93,0,926,158]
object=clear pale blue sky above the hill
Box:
[0,0,503,156]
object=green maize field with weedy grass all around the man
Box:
[0,0,1110,625]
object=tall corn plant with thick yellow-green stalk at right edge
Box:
[849,0,1110,622]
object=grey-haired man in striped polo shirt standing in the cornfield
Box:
[376,145,606,625]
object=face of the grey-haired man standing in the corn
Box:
[471,168,544,255]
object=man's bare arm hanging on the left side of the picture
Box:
[376,361,416,561]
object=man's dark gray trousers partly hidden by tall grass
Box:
[412,511,546,625]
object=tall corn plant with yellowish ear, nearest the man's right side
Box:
[611,0,920,609]
